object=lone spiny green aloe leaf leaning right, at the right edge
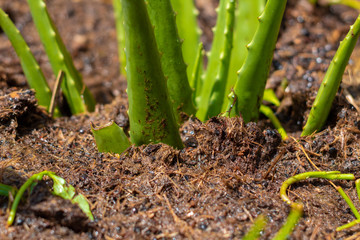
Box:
[301,15,360,136]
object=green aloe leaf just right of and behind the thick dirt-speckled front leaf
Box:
[145,0,195,123]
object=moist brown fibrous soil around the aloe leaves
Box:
[0,0,360,239]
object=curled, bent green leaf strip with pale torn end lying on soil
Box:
[7,171,94,226]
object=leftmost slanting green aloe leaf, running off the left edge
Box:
[0,9,60,116]
